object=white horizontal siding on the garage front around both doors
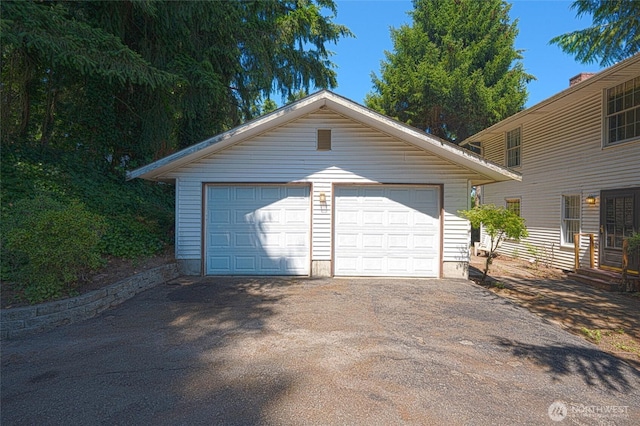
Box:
[168,111,472,268]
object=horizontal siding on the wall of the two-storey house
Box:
[483,84,640,269]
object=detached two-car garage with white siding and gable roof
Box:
[128,91,520,277]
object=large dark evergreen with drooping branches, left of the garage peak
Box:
[0,0,351,167]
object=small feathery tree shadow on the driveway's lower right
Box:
[494,336,640,393]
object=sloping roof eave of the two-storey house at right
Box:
[460,53,640,146]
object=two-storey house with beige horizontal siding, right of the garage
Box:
[463,54,640,273]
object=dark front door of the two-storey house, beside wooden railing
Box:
[600,188,640,273]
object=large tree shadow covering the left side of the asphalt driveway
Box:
[1,277,296,425]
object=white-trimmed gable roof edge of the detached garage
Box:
[127,90,522,184]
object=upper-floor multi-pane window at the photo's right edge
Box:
[605,77,640,145]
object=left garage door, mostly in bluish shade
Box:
[205,185,311,275]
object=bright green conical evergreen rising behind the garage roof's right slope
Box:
[365,0,533,142]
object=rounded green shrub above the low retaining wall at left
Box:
[2,195,105,303]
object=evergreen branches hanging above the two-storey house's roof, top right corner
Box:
[551,0,640,67]
